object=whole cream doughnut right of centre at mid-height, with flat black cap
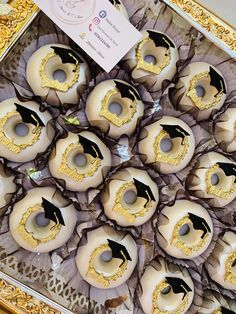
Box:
[138,116,195,174]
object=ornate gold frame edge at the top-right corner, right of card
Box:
[163,0,236,58]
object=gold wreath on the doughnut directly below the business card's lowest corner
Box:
[99,88,137,127]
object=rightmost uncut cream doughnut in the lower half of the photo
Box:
[157,200,213,259]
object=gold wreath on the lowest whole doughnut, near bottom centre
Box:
[87,244,128,288]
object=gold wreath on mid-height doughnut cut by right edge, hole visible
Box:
[205,164,236,200]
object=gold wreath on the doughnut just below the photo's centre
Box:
[112,182,152,223]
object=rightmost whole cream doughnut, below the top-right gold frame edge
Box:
[172,62,227,121]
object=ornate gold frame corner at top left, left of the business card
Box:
[0,0,39,62]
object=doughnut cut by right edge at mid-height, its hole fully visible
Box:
[186,152,236,207]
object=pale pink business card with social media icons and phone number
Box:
[34,0,142,72]
